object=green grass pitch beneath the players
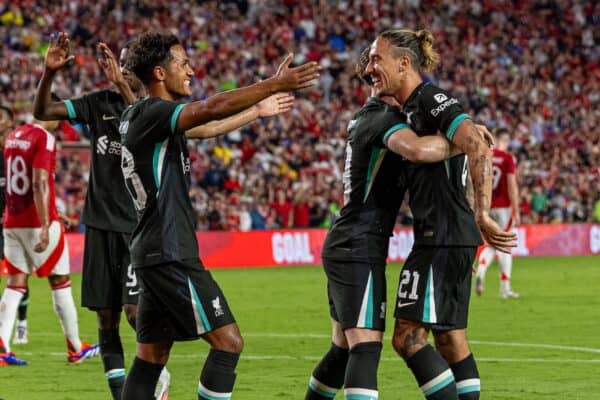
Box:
[0,257,600,400]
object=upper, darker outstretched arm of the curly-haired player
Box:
[177,54,319,131]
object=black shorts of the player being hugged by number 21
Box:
[323,258,386,332]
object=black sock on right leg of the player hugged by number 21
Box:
[344,342,383,398]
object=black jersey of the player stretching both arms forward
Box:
[119,98,198,267]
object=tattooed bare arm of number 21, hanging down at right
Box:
[452,119,516,253]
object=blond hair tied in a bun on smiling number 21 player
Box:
[379,29,440,72]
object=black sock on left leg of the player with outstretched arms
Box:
[122,357,164,400]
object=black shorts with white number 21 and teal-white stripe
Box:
[394,246,477,330]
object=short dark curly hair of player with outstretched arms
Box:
[126,32,181,84]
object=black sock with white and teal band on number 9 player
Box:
[98,329,125,400]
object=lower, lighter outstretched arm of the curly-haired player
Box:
[185,93,294,139]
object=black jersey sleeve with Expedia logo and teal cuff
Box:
[420,85,471,140]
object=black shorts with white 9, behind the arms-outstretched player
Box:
[81,226,140,310]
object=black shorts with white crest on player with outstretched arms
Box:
[136,259,235,343]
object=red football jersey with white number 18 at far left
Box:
[4,124,58,228]
